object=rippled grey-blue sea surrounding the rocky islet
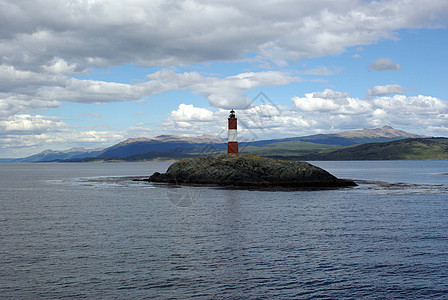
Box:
[0,161,448,299]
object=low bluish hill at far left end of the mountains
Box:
[16,147,102,162]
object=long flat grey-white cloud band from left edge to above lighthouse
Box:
[0,69,301,115]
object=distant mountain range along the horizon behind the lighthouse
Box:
[0,126,448,162]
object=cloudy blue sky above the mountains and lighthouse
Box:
[0,0,448,158]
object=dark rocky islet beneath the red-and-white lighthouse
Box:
[148,154,356,188]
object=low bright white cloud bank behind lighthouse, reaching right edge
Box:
[159,89,448,140]
